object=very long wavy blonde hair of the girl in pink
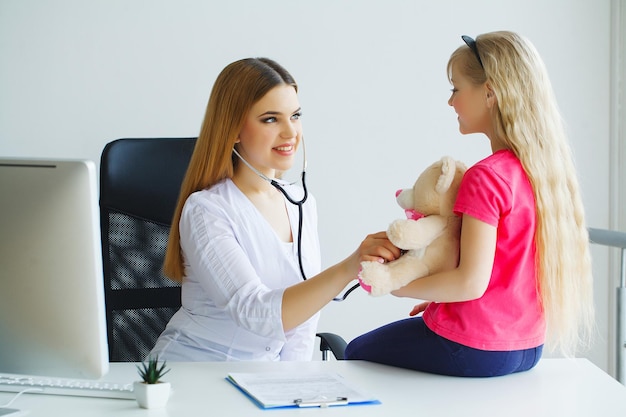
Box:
[447,32,595,356]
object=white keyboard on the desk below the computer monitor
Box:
[0,375,135,400]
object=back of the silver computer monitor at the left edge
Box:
[0,157,109,379]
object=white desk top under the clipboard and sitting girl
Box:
[0,359,626,417]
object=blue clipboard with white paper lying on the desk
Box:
[226,372,380,409]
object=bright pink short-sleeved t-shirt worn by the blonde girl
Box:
[423,150,545,351]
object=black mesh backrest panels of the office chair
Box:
[107,211,178,362]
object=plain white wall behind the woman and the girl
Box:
[0,0,612,369]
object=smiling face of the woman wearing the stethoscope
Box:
[237,85,302,178]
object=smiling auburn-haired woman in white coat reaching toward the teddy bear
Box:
[151,58,398,361]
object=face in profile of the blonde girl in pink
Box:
[448,66,491,136]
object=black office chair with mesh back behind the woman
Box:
[100,138,346,362]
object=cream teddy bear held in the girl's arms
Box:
[359,156,467,296]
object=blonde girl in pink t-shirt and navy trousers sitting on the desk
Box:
[346,32,594,377]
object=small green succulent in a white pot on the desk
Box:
[133,356,170,408]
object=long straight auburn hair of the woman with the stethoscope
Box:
[163,58,298,282]
